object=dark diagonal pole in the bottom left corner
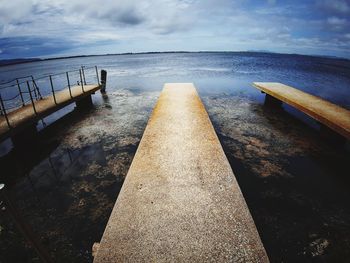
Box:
[0,184,52,262]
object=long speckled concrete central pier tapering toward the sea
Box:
[94,83,268,263]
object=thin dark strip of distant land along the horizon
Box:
[0,50,350,67]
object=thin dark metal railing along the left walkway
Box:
[0,66,100,128]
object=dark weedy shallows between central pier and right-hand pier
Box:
[204,96,350,262]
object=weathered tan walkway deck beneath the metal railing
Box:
[0,85,101,142]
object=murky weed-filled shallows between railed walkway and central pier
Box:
[0,90,158,262]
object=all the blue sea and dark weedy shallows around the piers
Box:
[0,53,350,262]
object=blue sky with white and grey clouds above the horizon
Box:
[0,0,350,59]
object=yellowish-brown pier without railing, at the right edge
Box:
[253,82,350,140]
